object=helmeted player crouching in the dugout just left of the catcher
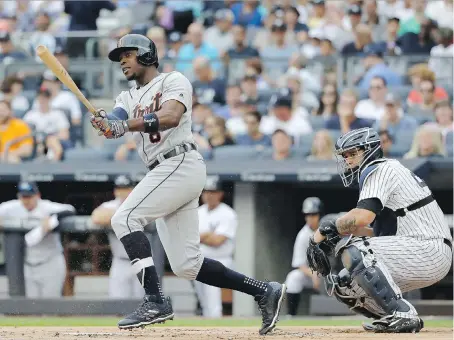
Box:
[285,197,323,316]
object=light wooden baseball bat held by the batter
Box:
[36,45,97,115]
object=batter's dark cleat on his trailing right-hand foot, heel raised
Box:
[255,282,287,335]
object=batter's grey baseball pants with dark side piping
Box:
[111,150,206,280]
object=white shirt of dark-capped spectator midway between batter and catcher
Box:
[260,113,312,138]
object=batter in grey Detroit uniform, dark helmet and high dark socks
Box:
[91,34,285,334]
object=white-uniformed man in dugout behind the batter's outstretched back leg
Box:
[195,179,238,318]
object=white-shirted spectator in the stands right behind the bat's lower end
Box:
[33,70,82,125]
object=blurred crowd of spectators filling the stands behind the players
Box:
[0,0,454,162]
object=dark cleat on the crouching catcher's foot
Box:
[363,315,424,333]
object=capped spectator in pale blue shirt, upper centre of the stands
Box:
[260,19,298,82]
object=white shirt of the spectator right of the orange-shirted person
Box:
[24,110,69,134]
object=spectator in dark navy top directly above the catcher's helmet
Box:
[325,89,373,133]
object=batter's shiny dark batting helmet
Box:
[109,34,159,67]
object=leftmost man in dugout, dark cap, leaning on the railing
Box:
[0,182,75,298]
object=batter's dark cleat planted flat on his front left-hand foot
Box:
[118,295,174,329]
